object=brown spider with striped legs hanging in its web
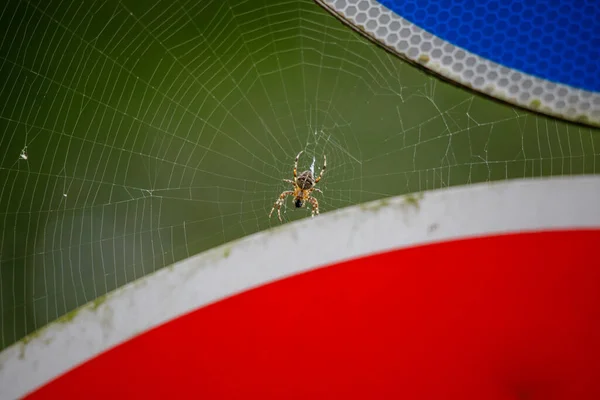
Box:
[269,151,327,222]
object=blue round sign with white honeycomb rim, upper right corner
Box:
[316,0,600,126]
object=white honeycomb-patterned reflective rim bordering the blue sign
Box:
[315,0,600,126]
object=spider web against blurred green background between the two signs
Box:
[0,0,599,349]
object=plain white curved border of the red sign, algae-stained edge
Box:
[0,176,600,399]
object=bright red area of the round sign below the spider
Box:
[29,231,600,400]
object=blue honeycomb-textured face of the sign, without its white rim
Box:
[378,0,600,92]
